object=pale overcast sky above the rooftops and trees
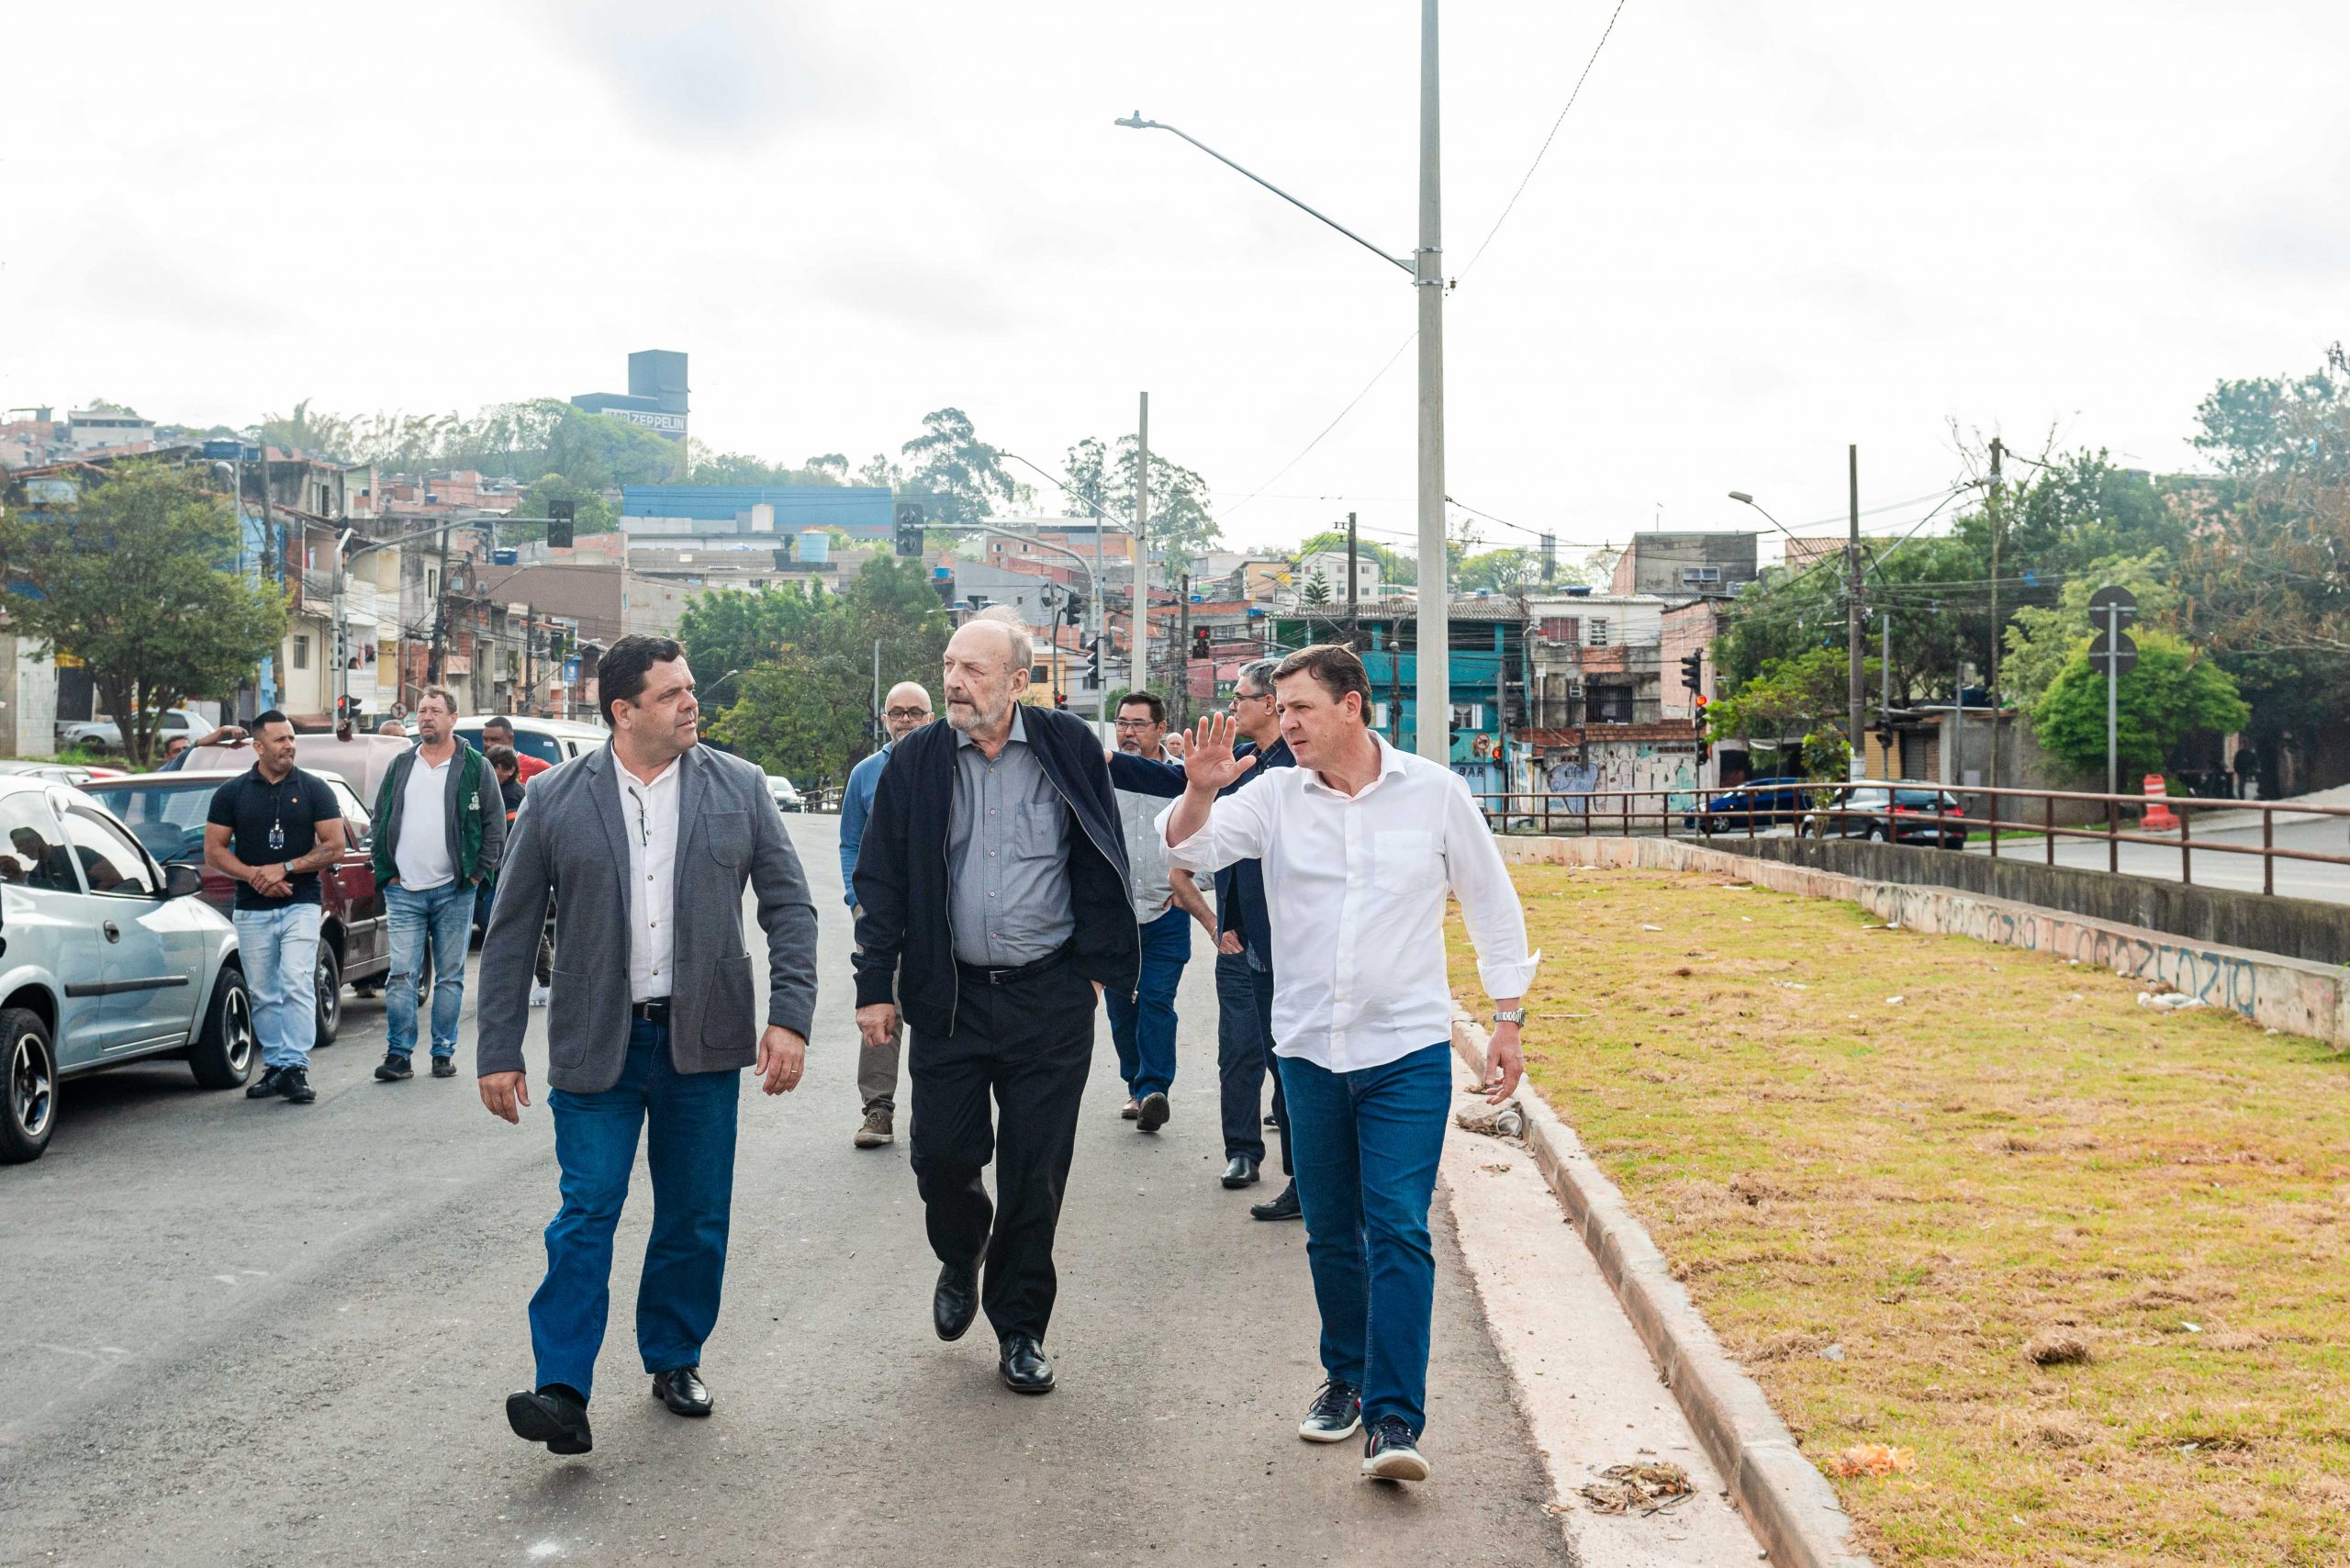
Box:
[0,0,2350,557]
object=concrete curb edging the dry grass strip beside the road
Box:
[1452,1009,1873,1568]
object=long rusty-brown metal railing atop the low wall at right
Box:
[1476,778,2350,893]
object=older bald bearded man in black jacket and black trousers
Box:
[856,621,1142,1394]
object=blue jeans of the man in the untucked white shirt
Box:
[1281,1044,1452,1437]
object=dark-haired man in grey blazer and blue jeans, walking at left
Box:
[479,637,815,1453]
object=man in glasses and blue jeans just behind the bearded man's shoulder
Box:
[1102,691,1215,1133]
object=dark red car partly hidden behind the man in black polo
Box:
[83,770,393,1047]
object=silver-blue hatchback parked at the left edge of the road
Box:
[0,776,256,1161]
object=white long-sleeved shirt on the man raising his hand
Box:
[1158,731,1541,1072]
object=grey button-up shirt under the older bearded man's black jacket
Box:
[947,708,1076,969]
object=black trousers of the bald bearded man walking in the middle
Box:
[907,964,1095,1340]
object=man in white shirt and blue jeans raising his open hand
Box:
[1158,644,1539,1481]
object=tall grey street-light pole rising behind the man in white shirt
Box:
[1398,0,1452,764]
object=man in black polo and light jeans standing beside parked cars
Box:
[205,708,343,1105]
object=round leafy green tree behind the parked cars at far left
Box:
[0,461,286,767]
